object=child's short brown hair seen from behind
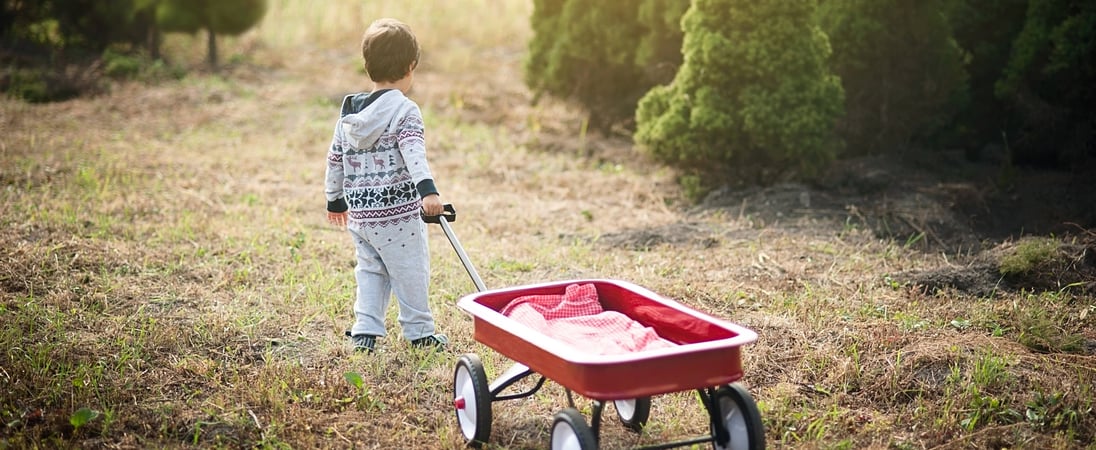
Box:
[362,19,419,82]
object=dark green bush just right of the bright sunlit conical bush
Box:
[819,0,967,155]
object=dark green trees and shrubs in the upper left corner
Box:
[0,0,266,102]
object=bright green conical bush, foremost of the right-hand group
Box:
[635,0,843,184]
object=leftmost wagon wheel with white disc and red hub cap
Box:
[453,354,491,447]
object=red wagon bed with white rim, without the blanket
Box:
[457,279,757,401]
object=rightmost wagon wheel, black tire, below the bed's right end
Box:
[711,384,765,450]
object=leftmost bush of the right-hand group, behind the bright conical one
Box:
[525,0,688,130]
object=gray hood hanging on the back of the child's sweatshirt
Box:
[339,90,406,149]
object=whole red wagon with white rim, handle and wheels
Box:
[435,209,765,450]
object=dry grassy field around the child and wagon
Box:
[0,0,1096,449]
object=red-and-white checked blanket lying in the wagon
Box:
[500,284,674,355]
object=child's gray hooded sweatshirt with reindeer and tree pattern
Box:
[324,90,437,229]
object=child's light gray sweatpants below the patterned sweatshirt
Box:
[349,220,434,339]
